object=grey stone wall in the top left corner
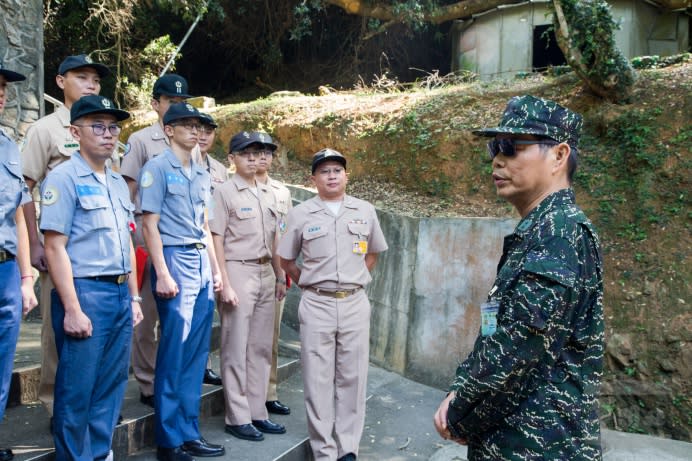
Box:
[0,0,43,139]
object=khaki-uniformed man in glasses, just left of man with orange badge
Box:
[209,131,286,441]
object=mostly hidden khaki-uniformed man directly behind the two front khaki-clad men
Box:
[255,138,293,415]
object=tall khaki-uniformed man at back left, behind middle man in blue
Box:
[22,54,110,418]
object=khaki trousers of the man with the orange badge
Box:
[298,290,370,461]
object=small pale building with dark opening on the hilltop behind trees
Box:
[451,0,692,79]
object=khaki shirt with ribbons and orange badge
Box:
[277,195,387,290]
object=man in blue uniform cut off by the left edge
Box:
[0,58,37,461]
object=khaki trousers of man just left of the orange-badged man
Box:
[220,261,276,426]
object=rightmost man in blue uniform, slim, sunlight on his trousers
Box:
[139,102,225,461]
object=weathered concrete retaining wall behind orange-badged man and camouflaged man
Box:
[284,188,517,388]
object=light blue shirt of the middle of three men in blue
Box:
[40,152,135,277]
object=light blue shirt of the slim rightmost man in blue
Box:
[139,149,211,246]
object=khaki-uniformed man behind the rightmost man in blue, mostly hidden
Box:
[120,74,218,408]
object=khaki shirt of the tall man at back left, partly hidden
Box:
[22,106,79,182]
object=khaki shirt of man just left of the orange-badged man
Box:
[209,175,278,261]
